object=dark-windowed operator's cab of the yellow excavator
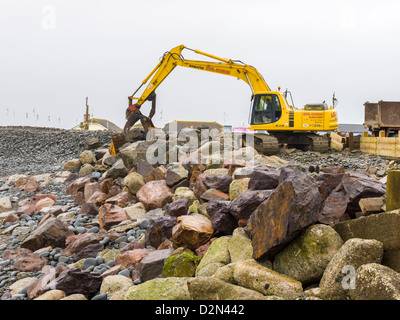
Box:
[251,93,282,125]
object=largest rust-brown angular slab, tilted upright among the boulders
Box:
[246,170,321,260]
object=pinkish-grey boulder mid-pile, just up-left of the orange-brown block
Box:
[136,180,173,210]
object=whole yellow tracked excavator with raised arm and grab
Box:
[115,45,338,155]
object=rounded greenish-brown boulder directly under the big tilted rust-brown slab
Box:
[273,224,343,284]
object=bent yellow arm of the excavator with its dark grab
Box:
[124,45,271,131]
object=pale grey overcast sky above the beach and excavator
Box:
[0,0,400,129]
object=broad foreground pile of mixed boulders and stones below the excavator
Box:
[0,128,400,300]
